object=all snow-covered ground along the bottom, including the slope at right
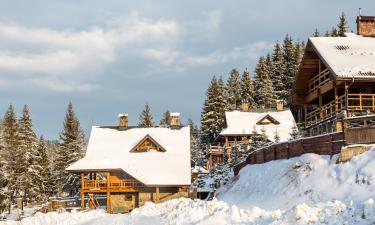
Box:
[0,147,375,225]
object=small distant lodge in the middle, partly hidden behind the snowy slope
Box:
[207,101,296,168]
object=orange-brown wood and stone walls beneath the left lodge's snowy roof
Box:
[77,170,188,213]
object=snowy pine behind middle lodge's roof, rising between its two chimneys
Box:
[254,56,275,108]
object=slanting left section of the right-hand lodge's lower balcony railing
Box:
[306,95,345,126]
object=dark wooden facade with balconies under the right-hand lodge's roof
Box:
[292,40,375,136]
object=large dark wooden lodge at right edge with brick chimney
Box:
[292,16,375,139]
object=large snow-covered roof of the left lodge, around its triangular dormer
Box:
[66,126,191,185]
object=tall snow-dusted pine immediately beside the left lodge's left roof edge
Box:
[54,102,85,195]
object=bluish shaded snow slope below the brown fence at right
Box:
[218,149,375,210]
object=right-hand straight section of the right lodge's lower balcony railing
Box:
[348,94,375,111]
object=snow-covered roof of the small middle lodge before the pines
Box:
[220,109,296,141]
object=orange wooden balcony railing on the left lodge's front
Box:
[82,180,144,190]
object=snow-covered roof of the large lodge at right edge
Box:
[309,35,375,79]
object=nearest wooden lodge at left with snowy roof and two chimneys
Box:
[66,113,191,213]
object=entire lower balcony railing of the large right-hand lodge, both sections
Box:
[306,94,375,126]
